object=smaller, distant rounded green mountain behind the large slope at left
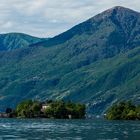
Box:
[0,33,45,51]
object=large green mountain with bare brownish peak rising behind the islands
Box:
[0,6,140,114]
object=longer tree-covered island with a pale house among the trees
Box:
[0,100,86,119]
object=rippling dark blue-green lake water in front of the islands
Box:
[0,119,140,140]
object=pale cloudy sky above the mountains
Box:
[0,0,140,38]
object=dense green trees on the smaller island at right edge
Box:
[106,101,140,120]
